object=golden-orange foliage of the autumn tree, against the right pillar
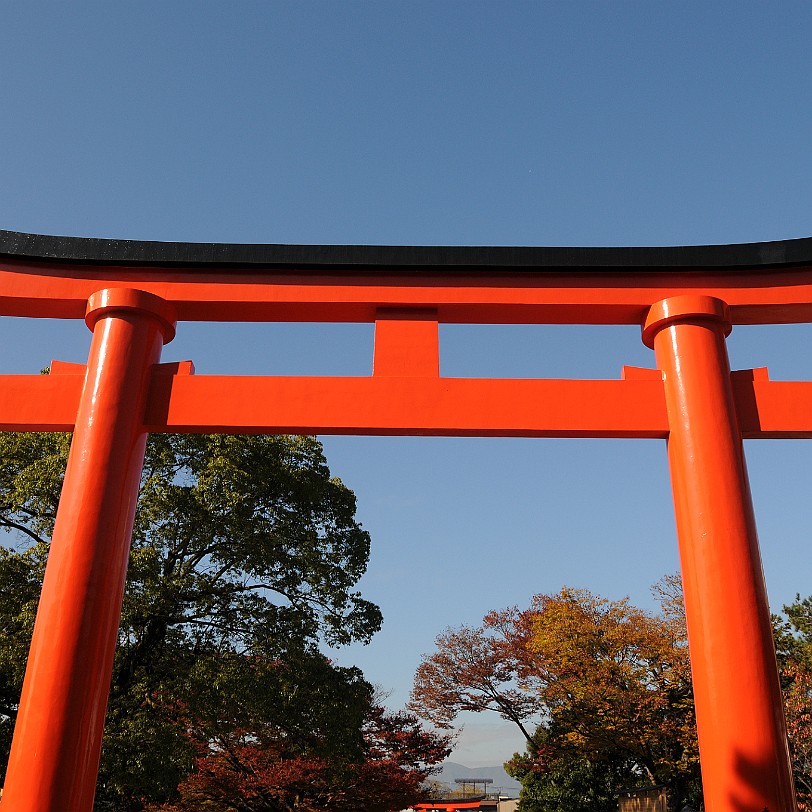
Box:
[519,589,699,803]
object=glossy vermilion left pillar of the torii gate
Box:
[0,288,175,812]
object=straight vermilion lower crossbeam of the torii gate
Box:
[0,364,812,439]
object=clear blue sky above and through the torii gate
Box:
[0,0,812,766]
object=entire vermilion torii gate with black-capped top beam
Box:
[0,232,812,812]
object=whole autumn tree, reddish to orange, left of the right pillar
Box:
[411,580,700,810]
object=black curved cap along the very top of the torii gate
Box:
[0,230,812,271]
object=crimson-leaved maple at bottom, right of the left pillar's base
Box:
[145,664,450,812]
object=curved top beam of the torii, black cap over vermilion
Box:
[0,231,812,324]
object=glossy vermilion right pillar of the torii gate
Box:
[643,296,797,812]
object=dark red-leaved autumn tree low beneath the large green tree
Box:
[144,656,450,812]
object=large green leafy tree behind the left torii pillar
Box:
[0,434,381,810]
